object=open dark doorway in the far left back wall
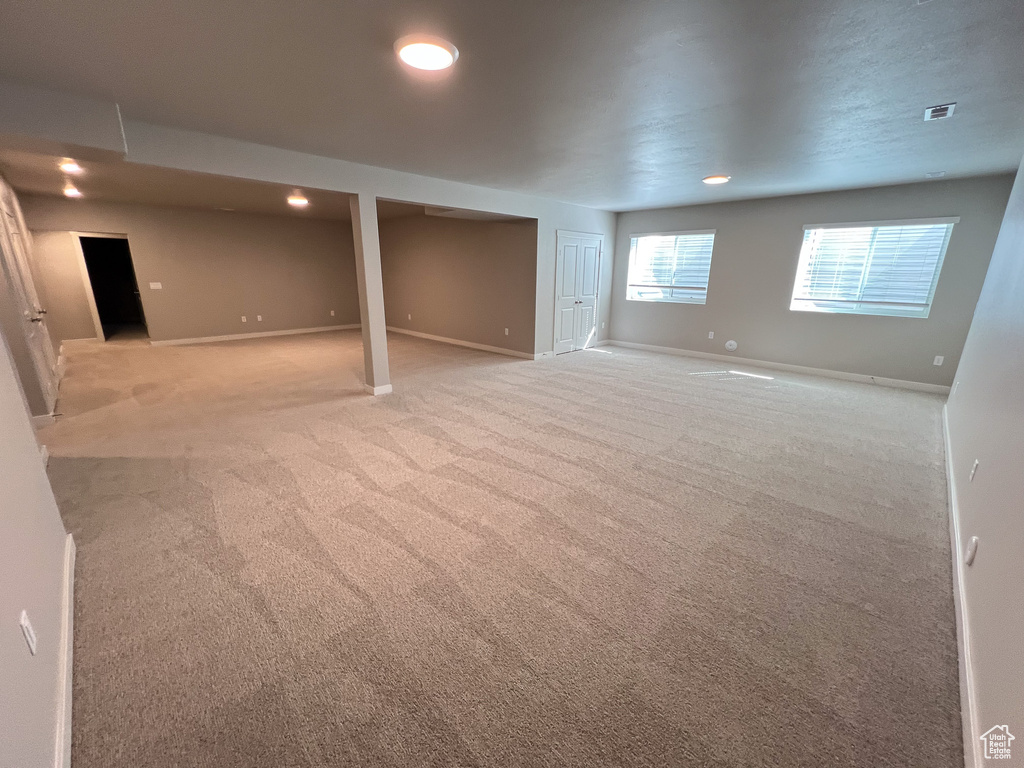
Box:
[79,237,150,340]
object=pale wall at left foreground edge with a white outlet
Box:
[0,325,69,766]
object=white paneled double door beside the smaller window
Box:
[555,232,601,354]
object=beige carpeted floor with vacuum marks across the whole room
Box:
[42,332,963,768]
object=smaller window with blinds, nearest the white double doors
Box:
[626,229,715,304]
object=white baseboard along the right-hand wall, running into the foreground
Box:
[942,406,981,768]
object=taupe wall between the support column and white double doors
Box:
[380,216,537,354]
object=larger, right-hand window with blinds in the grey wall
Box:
[790,218,959,317]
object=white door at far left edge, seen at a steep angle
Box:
[0,181,57,412]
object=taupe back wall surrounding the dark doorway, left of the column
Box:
[22,195,359,341]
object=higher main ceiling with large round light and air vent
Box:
[0,0,1024,210]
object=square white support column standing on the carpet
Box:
[349,193,391,394]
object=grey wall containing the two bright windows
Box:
[611,176,1013,386]
